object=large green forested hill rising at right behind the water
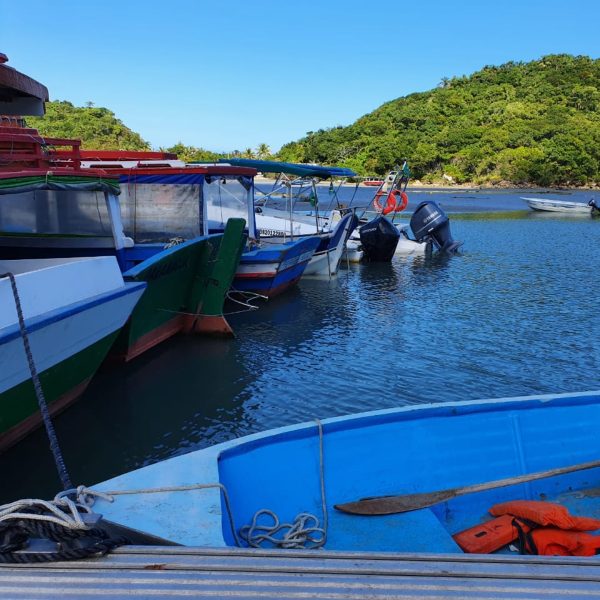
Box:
[278,55,600,186]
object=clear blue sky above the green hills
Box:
[0,0,600,151]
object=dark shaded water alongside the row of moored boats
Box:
[0,280,348,502]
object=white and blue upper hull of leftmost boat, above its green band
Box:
[0,257,146,393]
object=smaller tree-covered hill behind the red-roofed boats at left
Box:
[27,100,150,150]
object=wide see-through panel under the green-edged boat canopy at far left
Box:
[0,190,113,238]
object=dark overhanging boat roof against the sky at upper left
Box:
[0,53,49,116]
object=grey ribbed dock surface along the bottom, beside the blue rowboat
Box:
[0,546,600,600]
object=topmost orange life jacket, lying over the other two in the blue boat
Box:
[490,500,600,531]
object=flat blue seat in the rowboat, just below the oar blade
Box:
[325,508,462,554]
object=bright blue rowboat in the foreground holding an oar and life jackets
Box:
[92,392,600,553]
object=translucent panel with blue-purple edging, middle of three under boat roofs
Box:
[119,181,203,244]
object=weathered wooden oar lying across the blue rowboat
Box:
[335,460,600,515]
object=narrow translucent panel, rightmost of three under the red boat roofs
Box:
[202,175,256,238]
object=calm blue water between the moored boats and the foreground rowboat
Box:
[0,192,600,501]
